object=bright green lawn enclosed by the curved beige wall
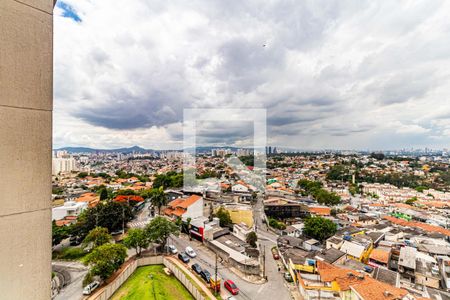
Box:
[111,265,194,300]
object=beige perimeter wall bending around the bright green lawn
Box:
[88,256,209,300]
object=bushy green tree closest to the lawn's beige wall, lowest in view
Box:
[83,243,127,280]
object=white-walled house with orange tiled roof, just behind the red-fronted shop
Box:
[164,195,203,220]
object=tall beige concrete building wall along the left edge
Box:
[0,0,53,300]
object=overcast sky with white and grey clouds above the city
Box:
[54,0,450,149]
